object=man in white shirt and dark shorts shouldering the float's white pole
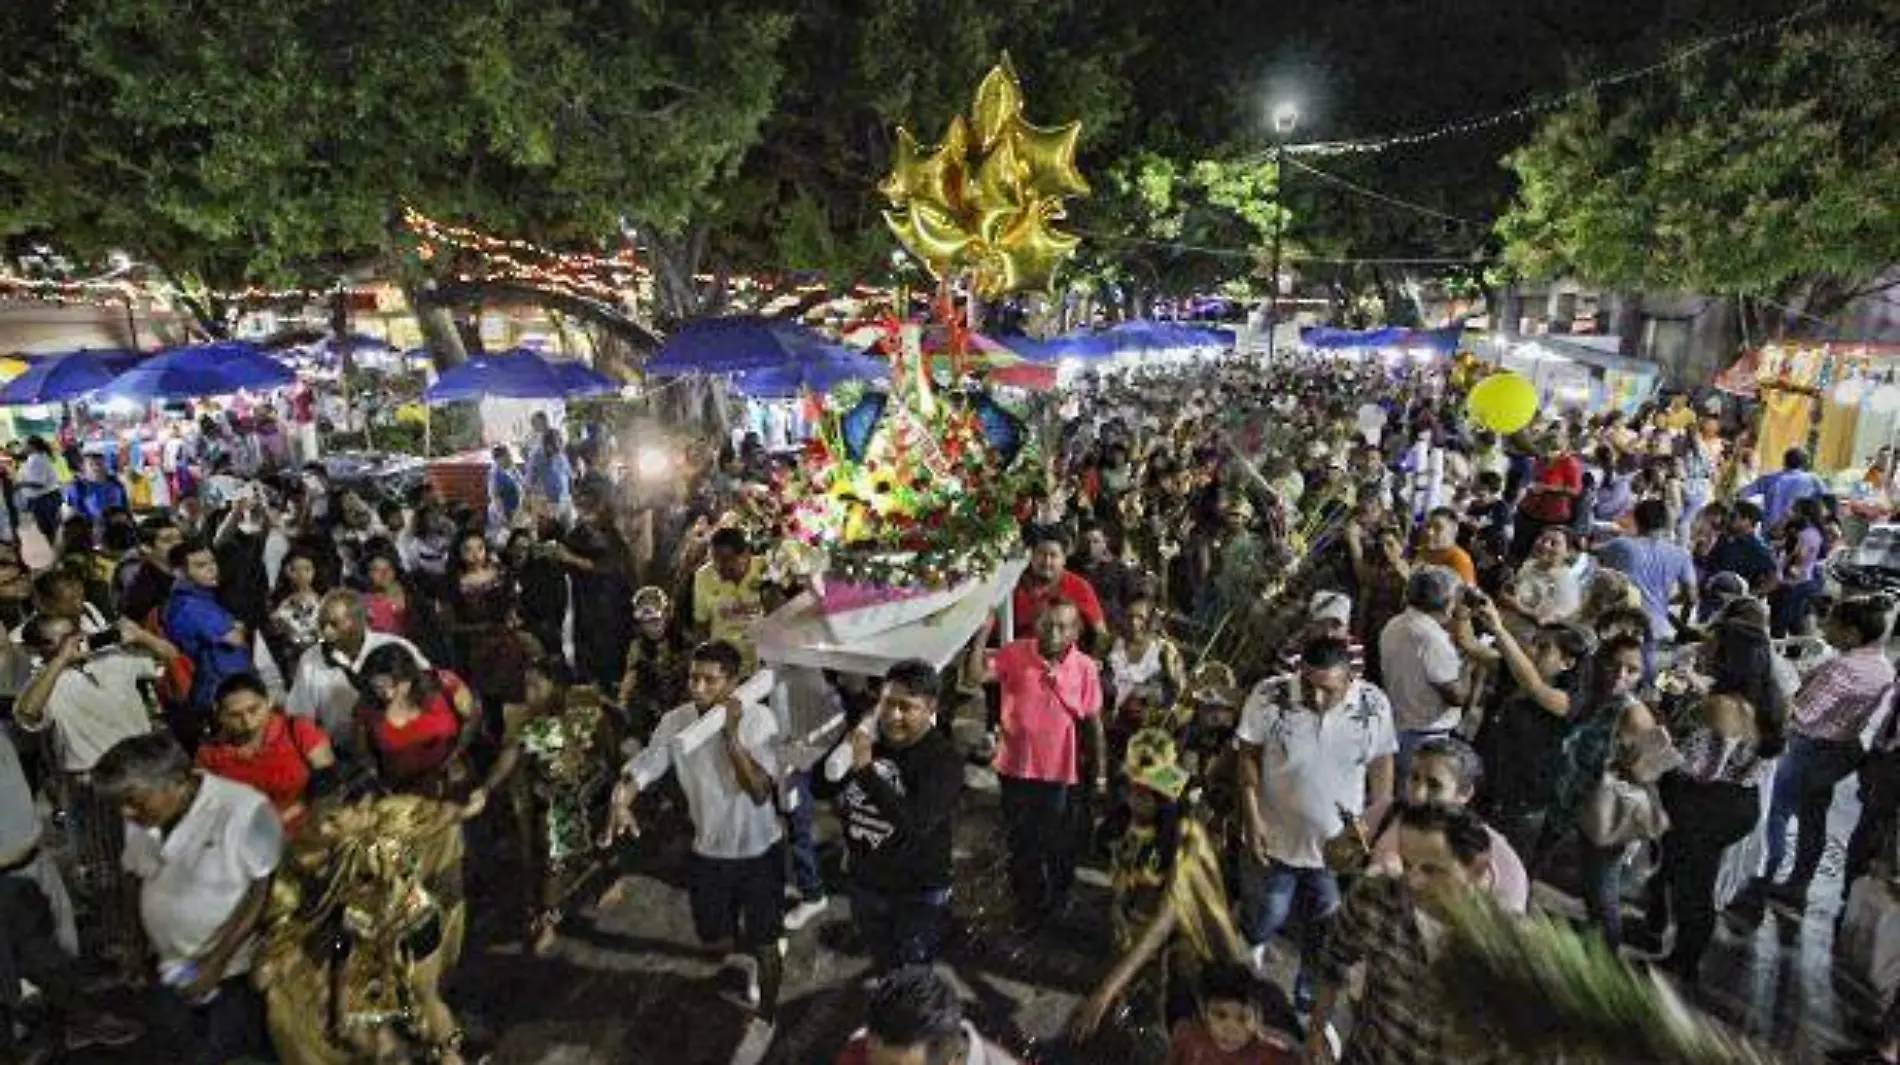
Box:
[612,640,785,1063]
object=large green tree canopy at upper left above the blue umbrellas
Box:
[0,0,790,285]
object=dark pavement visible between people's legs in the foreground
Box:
[55,717,1870,1065]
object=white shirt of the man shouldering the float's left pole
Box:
[627,702,781,858]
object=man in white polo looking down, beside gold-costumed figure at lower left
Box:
[93,733,283,1065]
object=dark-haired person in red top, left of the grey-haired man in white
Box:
[198,674,336,835]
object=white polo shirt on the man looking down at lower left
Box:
[124,773,283,976]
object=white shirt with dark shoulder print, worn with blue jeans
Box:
[1237,676,1398,869]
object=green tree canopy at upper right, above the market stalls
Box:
[1499,0,1900,313]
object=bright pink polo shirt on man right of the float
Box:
[990,640,1102,784]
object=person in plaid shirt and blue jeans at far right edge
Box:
[1761,596,1894,913]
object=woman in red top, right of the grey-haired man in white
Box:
[357,645,485,804]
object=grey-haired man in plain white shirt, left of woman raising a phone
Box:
[1379,566,1471,780]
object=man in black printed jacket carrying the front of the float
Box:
[828,661,963,972]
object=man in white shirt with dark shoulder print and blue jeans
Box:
[1237,638,1398,1004]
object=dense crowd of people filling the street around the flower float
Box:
[0,361,1900,1065]
